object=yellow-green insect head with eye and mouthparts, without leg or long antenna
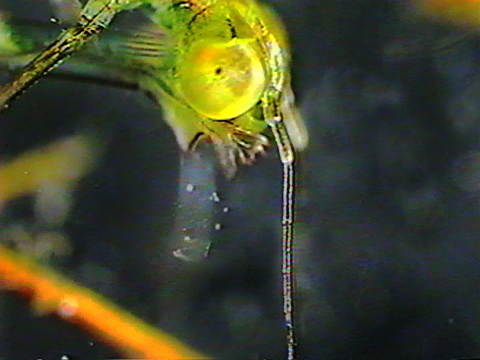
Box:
[115,0,305,177]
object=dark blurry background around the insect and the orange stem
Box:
[0,0,480,360]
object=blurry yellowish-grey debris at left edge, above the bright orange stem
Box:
[0,134,99,262]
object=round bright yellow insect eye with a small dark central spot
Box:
[177,39,266,120]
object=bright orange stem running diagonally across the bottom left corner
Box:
[0,245,207,360]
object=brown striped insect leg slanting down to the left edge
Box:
[0,0,143,111]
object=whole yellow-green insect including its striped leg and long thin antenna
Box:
[0,0,308,359]
